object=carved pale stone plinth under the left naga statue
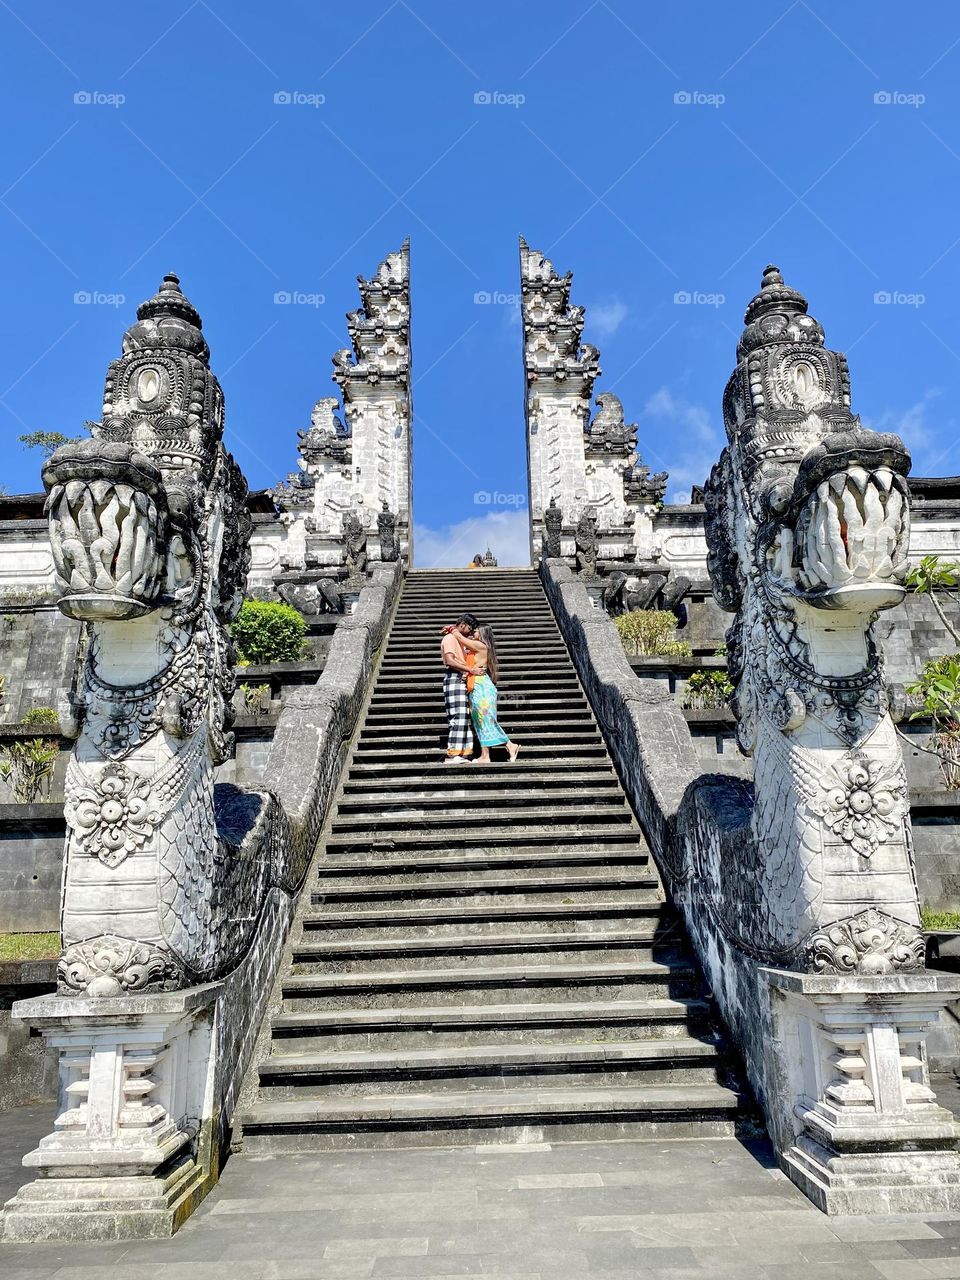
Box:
[4,983,220,1242]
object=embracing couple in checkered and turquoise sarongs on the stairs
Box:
[440,613,520,764]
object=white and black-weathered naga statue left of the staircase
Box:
[44,275,289,996]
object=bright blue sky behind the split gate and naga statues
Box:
[0,0,960,564]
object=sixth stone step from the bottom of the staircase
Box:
[301,893,672,942]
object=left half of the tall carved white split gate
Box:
[273,239,412,568]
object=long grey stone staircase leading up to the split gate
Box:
[239,570,744,1152]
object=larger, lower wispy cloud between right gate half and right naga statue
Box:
[639,387,724,502]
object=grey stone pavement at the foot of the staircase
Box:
[0,1082,960,1280]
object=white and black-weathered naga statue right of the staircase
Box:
[704,266,924,974]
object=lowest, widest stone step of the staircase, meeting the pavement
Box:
[242,1084,740,1155]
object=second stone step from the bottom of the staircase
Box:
[252,1037,722,1102]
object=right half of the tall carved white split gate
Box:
[520,237,667,559]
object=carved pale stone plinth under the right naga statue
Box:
[773,969,960,1213]
